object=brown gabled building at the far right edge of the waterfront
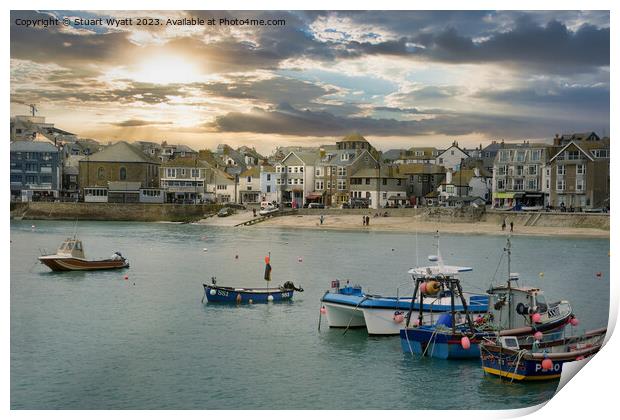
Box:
[549,139,610,211]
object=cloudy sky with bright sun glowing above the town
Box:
[10,11,610,153]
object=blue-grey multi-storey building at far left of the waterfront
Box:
[10,140,61,201]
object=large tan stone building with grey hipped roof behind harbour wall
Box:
[79,141,163,203]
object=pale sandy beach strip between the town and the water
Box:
[251,215,609,238]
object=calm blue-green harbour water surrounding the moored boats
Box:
[11,221,609,409]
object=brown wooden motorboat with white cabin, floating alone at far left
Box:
[39,237,129,271]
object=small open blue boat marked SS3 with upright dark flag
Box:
[202,254,304,304]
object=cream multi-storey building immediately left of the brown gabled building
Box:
[492,142,553,208]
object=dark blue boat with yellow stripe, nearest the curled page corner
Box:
[480,328,607,381]
